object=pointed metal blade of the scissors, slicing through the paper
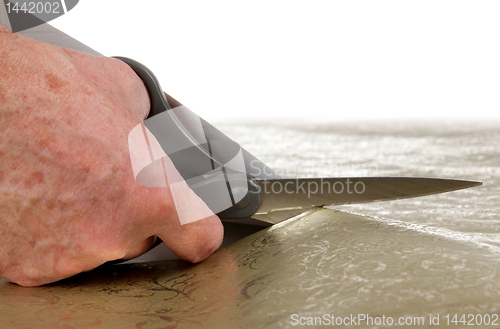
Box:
[252,177,482,224]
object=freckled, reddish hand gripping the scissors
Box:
[0,25,223,286]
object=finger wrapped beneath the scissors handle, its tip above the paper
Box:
[129,125,224,262]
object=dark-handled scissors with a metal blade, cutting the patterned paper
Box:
[108,57,482,263]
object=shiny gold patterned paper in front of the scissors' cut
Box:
[0,209,500,328]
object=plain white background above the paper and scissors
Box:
[51,0,500,122]
